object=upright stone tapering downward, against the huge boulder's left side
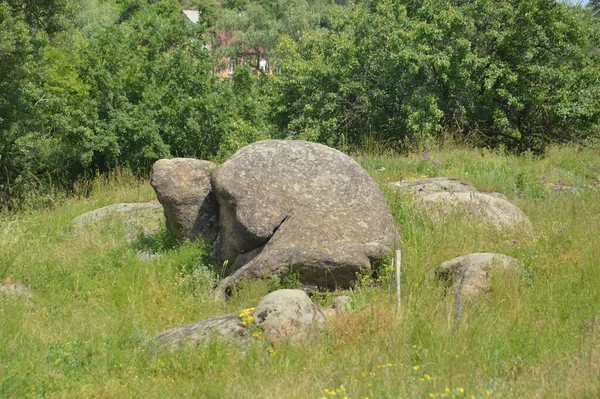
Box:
[150,158,219,244]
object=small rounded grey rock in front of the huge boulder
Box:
[252,289,326,341]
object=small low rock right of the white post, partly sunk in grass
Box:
[435,253,524,296]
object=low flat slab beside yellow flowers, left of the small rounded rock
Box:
[153,313,250,346]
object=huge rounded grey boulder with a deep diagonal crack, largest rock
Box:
[212,140,395,289]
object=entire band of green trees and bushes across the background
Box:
[0,0,600,207]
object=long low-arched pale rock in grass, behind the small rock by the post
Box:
[413,192,533,234]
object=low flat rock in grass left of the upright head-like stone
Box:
[71,200,165,242]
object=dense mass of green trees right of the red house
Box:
[273,0,600,151]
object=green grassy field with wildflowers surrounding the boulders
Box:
[0,146,600,398]
